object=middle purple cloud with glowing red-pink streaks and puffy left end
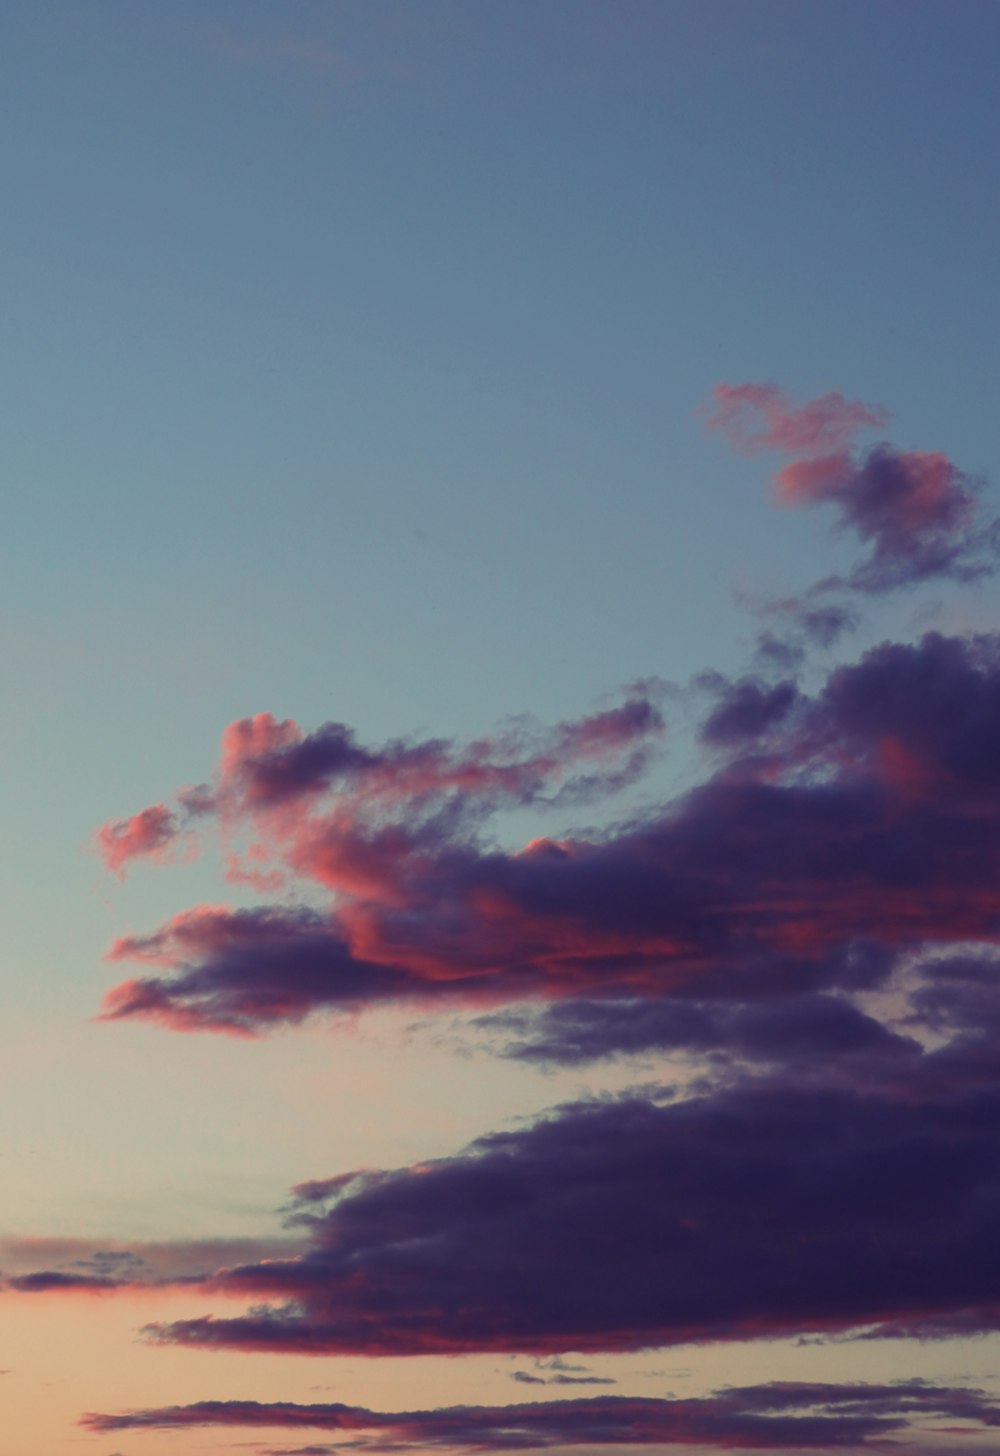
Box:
[93,633,1000,1035]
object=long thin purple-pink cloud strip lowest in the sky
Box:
[82,1380,1000,1453]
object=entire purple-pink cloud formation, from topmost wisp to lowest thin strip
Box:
[50,384,1000,1452]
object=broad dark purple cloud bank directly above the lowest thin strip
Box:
[23,920,1000,1351]
